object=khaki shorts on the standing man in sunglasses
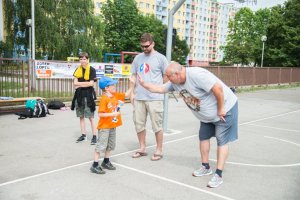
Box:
[133,100,164,133]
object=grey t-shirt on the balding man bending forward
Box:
[164,67,237,123]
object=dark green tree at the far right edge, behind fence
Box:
[264,0,300,67]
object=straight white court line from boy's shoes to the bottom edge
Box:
[114,162,233,200]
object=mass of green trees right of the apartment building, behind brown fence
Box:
[221,0,300,67]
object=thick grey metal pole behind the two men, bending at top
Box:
[163,0,185,132]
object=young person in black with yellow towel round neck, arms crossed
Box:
[71,52,97,145]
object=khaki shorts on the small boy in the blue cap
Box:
[95,128,116,153]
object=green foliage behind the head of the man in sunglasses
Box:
[102,0,189,64]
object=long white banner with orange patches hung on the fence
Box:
[34,60,131,78]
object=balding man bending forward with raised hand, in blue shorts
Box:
[138,62,238,188]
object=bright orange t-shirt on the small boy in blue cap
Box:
[97,92,125,129]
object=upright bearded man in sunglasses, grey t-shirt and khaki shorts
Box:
[130,33,168,160]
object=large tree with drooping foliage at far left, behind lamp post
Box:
[5,0,104,60]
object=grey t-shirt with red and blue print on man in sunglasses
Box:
[131,51,168,101]
